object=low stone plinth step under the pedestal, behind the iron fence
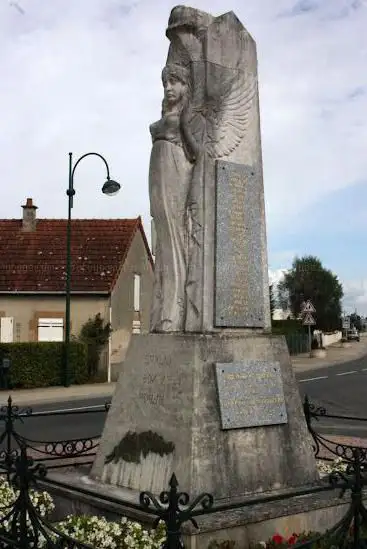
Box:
[39,471,367,549]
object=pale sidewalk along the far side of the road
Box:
[0,334,367,406]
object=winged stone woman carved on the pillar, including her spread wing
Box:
[149,51,257,332]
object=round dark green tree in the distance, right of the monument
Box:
[278,255,343,331]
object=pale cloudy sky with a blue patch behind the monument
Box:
[0,0,367,314]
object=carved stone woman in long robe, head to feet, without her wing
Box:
[149,64,198,332]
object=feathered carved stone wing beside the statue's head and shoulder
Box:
[191,67,257,158]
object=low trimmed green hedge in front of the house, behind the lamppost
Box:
[0,342,88,389]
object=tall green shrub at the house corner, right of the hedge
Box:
[79,313,112,377]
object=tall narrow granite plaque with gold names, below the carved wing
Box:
[214,160,265,328]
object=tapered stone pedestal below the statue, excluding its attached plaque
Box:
[91,332,319,501]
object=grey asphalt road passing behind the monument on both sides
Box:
[0,356,367,441]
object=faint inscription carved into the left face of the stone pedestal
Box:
[138,354,180,407]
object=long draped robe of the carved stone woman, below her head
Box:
[149,113,192,332]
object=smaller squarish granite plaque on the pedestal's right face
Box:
[215,360,288,429]
